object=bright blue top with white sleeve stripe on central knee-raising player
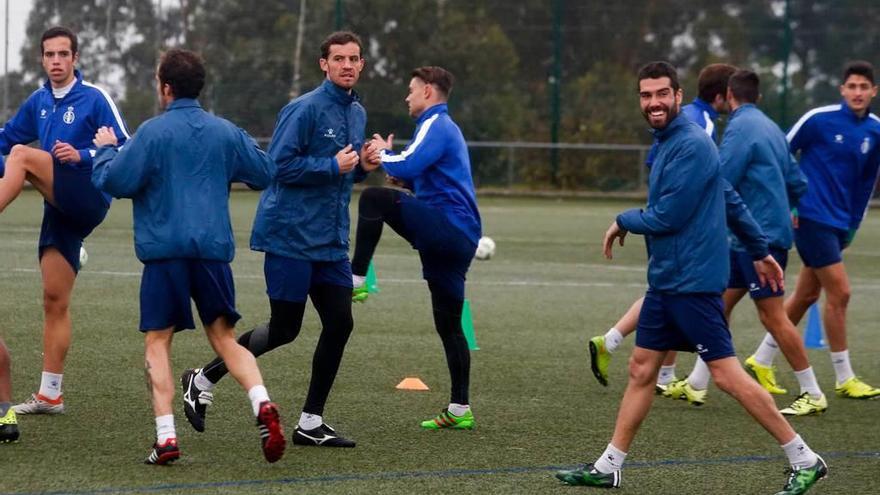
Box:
[382,103,482,244]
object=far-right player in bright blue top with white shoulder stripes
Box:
[755,61,880,399]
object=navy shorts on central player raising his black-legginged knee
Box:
[400,194,477,300]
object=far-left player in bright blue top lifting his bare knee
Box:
[0,27,128,414]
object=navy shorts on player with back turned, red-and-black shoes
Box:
[140,259,241,332]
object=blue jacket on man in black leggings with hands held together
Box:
[251,80,367,261]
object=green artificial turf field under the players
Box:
[0,191,880,495]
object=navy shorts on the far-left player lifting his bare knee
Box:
[39,160,110,273]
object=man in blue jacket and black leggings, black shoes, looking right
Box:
[181,31,378,447]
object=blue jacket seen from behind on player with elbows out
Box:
[92,98,275,262]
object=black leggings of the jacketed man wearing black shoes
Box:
[204,285,354,416]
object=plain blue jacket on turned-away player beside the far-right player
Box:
[718,104,807,251]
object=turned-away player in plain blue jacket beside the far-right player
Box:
[664,70,828,416]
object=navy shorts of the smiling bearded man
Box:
[636,291,736,362]
